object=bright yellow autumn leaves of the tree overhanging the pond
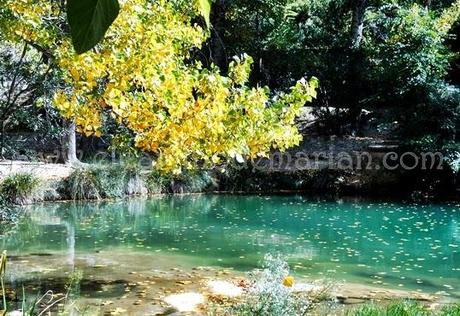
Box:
[0,0,317,173]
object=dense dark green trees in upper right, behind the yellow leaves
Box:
[210,0,460,164]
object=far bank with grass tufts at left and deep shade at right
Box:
[0,151,459,204]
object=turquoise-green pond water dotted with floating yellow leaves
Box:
[0,196,460,298]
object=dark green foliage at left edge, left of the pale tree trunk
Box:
[0,44,64,157]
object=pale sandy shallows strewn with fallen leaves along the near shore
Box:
[1,250,453,315]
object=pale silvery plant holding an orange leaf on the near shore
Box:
[228,254,312,316]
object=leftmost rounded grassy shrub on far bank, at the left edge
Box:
[0,173,41,204]
